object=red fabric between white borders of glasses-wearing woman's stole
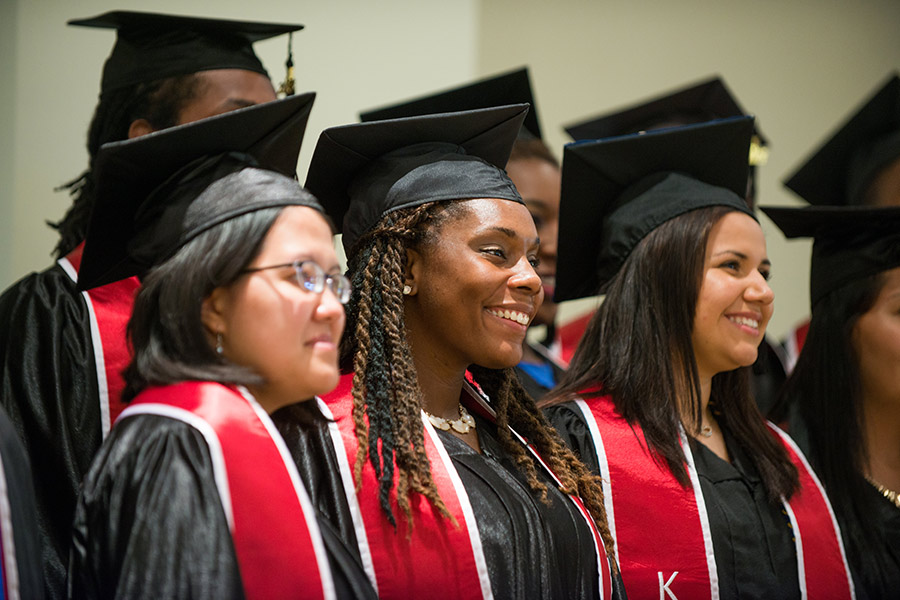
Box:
[133,382,324,600]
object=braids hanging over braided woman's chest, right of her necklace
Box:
[469,365,617,570]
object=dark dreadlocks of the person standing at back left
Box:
[47,73,202,258]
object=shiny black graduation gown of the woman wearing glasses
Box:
[69,408,375,600]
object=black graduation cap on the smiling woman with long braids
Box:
[306,104,528,252]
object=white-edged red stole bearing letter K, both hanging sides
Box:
[576,397,855,600]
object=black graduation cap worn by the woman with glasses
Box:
[78,93,322,290]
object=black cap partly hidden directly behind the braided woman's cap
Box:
[359,67,541,139]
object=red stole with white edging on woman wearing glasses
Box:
[122,382,335,600]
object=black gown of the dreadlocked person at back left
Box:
[0,265,102,598]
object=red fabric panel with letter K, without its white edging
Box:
[586,397,710,600]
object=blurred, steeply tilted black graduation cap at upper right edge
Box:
[784,74,900,206]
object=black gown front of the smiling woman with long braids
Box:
[438,415,625,599]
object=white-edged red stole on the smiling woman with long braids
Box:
[324,374,611,599]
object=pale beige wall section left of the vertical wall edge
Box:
[0,0,478,288]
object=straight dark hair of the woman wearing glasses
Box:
[122,208,282,402]
